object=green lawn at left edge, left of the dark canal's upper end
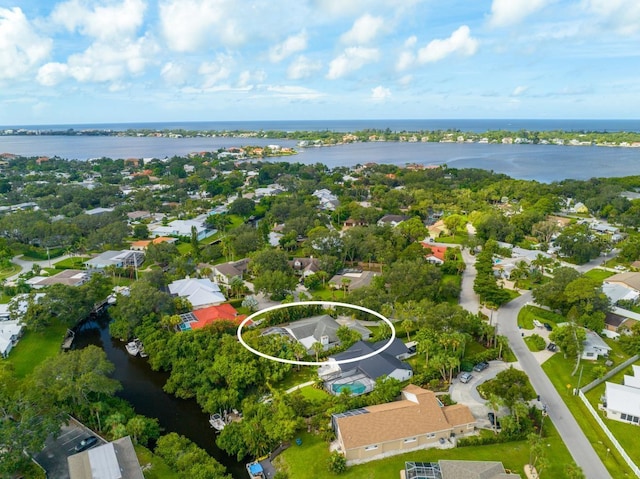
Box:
[6,321,67,378]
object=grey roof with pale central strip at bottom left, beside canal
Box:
[67,436,144,479]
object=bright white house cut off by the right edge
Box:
[602,364,640,426]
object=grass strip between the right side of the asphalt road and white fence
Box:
[542,353,634,478]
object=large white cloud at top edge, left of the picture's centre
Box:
[159,0,245,52]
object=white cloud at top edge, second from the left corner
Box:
[51,0,146,41]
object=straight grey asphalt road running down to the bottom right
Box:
[498,292,611,479]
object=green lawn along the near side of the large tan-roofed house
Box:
[275,421,571,479]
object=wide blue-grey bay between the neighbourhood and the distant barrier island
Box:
[0,136,640,183]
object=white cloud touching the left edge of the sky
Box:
[0,7,53,80]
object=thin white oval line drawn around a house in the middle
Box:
[237,301,396,366]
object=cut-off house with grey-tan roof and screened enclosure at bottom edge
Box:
[400,460,520,479]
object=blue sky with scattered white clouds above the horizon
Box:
[0,0,640,125]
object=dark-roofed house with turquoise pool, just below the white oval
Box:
[318,338,413,395]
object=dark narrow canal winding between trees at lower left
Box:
[73,314,247,479]
